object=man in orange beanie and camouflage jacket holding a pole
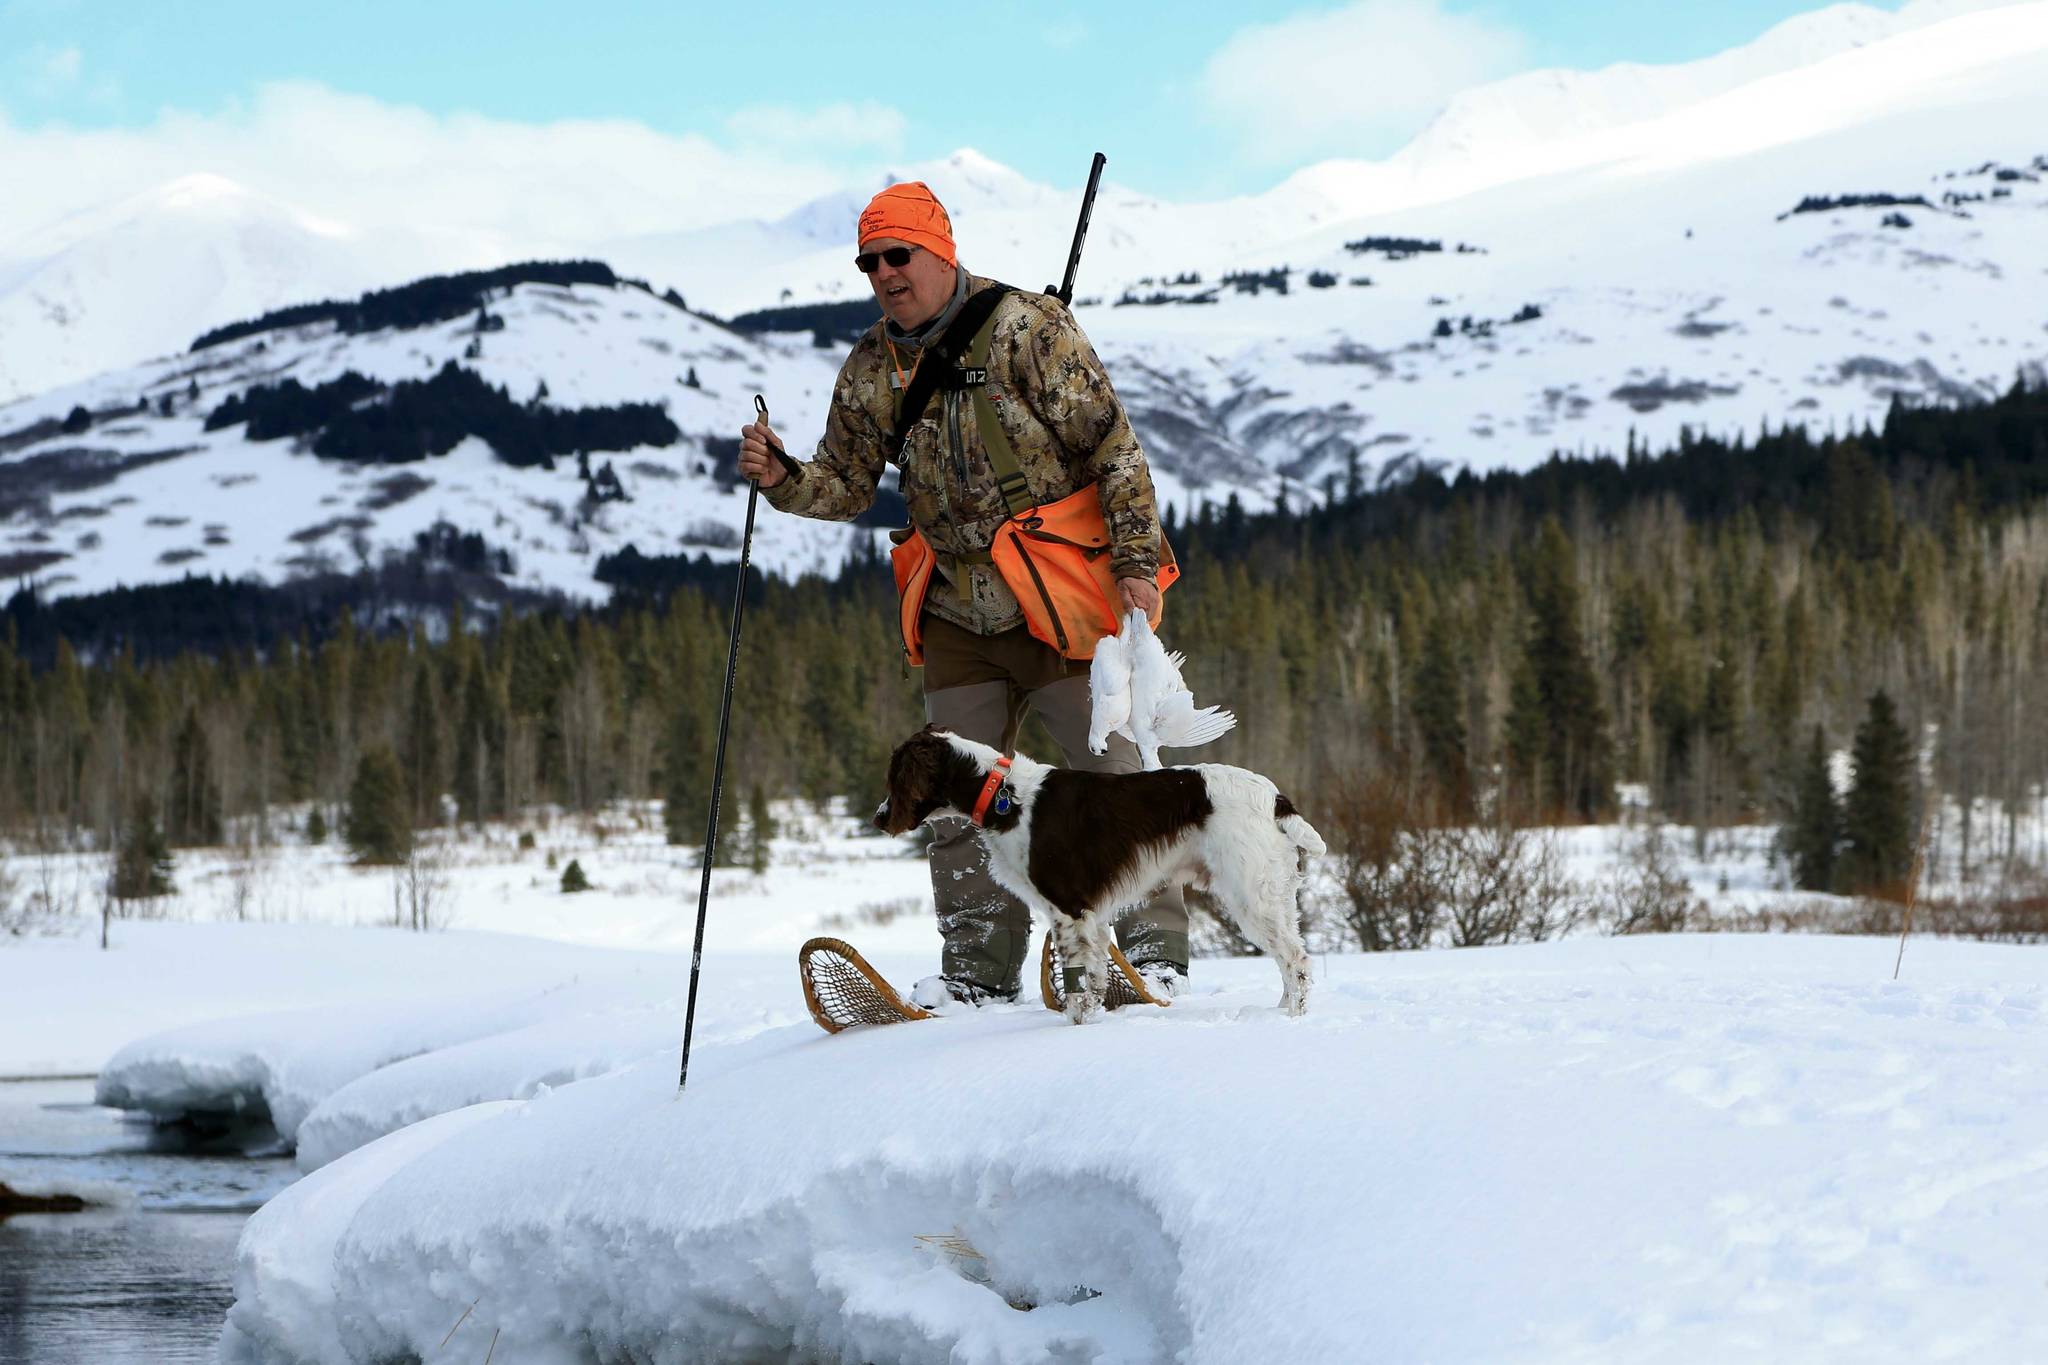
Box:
[739,182,1188,1009]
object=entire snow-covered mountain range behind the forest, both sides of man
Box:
[0,2,2048,593]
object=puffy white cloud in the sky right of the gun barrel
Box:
[1202,0,1530,166]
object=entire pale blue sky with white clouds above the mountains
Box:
[0,0,2013,266]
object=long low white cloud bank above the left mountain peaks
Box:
[0,82,903,256]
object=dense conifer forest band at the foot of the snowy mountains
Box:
[12,383,2048,925]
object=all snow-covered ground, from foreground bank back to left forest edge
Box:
[0,806,2048,1363]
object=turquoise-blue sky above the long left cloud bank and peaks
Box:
[0,0,1898,199]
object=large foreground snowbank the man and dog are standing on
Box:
[223,935,2048,1365]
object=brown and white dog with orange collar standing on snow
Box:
[874,726,1325,1023]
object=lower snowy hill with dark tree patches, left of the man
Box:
[0,272,864,598]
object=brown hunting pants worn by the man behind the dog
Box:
[924,612,1188,995]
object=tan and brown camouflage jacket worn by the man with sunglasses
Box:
[762,276,1159,634]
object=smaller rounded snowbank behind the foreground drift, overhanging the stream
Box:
[79,927,899,1171]
